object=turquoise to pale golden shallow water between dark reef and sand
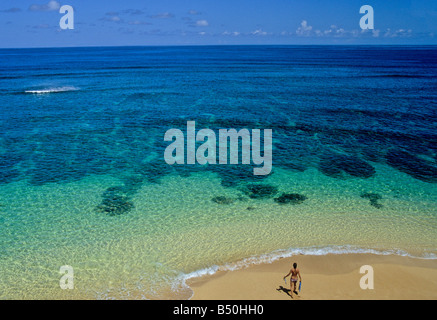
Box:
[1,166,436,299]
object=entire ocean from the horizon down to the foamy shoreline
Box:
[0,46,437,299]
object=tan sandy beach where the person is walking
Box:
[188,254,437,300]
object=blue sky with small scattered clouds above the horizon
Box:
[0,0,437,48]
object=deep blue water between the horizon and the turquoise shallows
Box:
[0,46,437,190]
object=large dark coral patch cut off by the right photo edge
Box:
[386,150,437,183]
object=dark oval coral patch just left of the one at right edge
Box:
[319,154,375,178]
